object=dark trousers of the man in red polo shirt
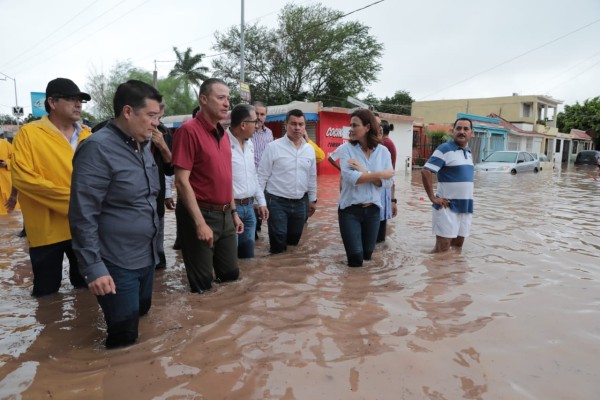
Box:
[175,201,240,293]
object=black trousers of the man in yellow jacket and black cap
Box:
[29,240,87,297]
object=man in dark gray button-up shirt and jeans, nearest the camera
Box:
[69,80,162,348]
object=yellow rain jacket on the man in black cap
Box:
[11,116,92,247]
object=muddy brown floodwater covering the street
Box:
[0,167,600,400]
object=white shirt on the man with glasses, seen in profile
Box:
[227,129,267,206]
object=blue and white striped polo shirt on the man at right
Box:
[424,141,475,213]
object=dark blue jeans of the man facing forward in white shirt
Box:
[265,192,307,254]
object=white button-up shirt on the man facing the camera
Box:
[258,135,317,201]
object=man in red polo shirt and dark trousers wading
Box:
[171,78,244,293]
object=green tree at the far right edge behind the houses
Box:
[556,96,600,149]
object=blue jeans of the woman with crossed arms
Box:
[338,205,379,267]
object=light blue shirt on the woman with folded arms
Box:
[336,142,394,209]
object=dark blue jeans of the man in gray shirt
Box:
[96,261,155,348]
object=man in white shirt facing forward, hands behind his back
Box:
[258,110,317,254]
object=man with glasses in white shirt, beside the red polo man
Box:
[227,104,269,258]
